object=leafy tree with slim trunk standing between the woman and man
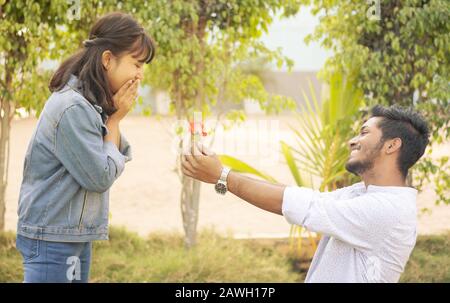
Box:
[142,0,298,247]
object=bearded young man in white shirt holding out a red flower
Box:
[183,106,429,282]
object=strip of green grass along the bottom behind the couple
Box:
[0,227,450,282]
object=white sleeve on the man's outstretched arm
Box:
[282,187,394,250]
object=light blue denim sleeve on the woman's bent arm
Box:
[55,104,130,192]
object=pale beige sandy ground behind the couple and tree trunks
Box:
[6,116,450,237]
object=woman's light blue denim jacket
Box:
[17,75,131,242]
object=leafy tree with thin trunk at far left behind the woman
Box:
[0,0,74,230]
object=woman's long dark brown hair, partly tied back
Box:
[49,12,155,115]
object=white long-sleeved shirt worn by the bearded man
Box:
[282,182,417,282]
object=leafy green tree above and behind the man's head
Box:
[302,0,450,203]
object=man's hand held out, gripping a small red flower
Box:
[181,144,223,183]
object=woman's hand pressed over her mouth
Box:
[109,80,140,122]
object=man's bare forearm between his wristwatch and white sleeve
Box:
[227,171,286,215]
